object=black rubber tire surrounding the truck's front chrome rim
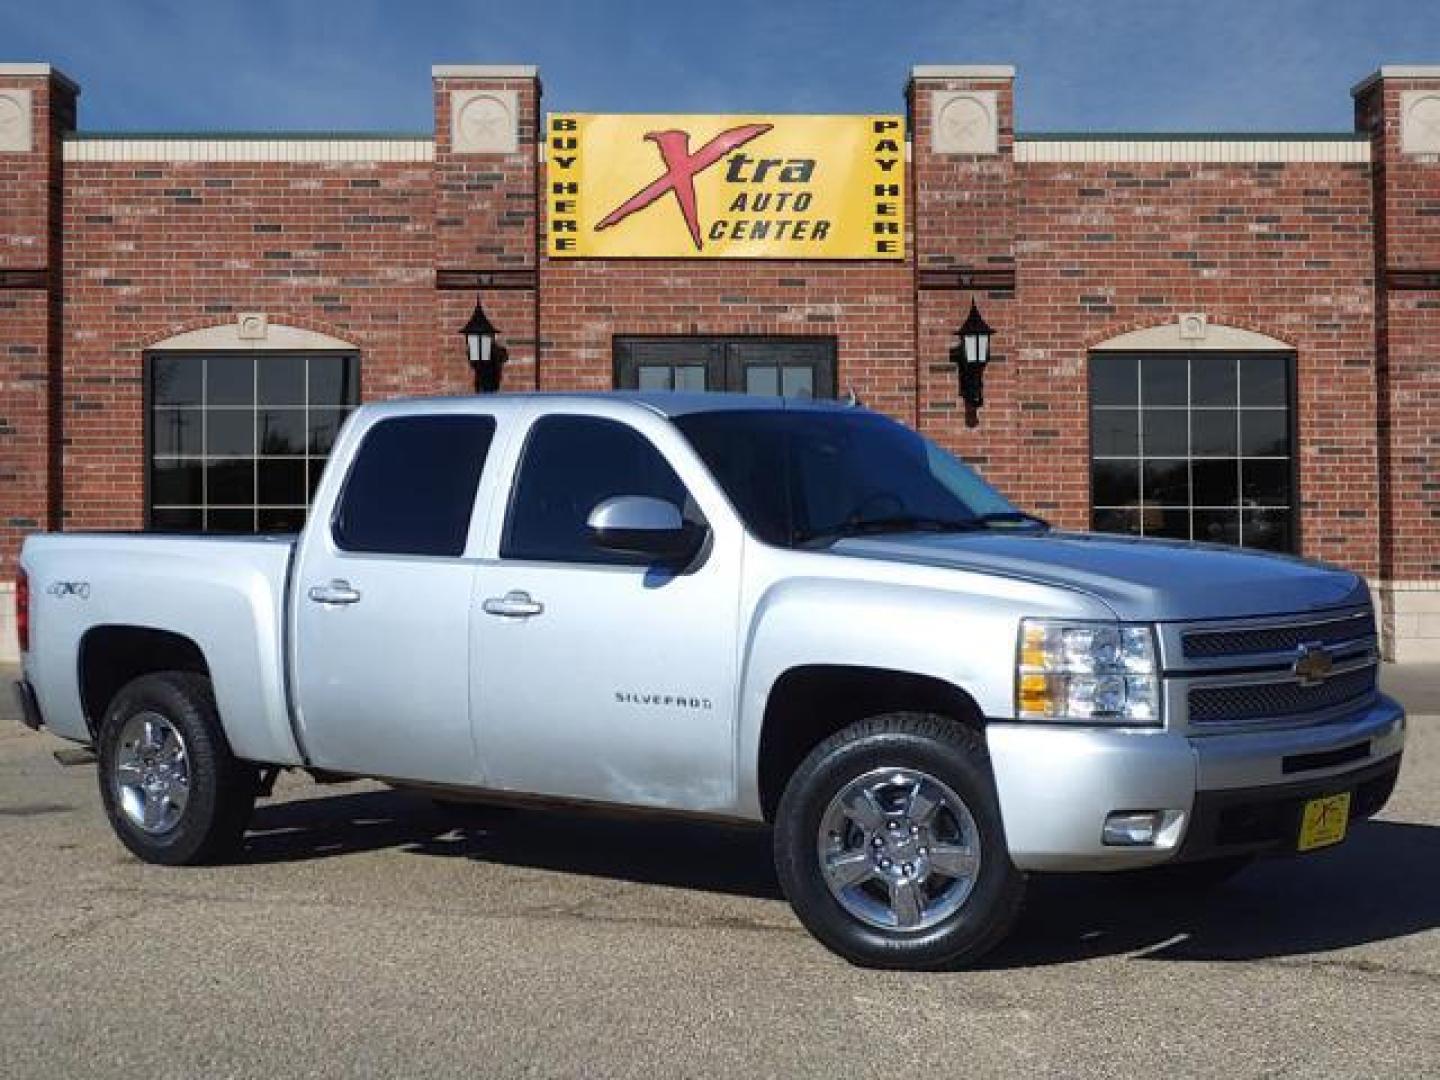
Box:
[775,713,1025,971]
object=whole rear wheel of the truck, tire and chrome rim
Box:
[98,671,259,865]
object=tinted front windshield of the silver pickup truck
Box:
[675,409,1044,547]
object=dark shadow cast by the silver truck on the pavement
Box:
[243,791,1440,969]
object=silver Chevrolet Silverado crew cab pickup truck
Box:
[19,395,1405,968]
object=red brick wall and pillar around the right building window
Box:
[913,74,1378,575]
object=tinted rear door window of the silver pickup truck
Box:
[333,416,495,556]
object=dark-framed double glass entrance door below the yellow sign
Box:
[615,337,835,397]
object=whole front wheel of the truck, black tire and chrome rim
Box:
[775,713,1024,969]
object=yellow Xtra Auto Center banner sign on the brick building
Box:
[546,112,904,259]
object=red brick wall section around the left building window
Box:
[65,161,443,528]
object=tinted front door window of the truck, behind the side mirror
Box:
[500,416,696,563]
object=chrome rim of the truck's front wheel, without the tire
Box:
[816,769,981,930]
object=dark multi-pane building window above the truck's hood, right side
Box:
[1090,351,1296,550]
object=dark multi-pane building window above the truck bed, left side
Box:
[147,353,360,533]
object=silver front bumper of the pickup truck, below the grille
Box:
[986,696,1405,871]
